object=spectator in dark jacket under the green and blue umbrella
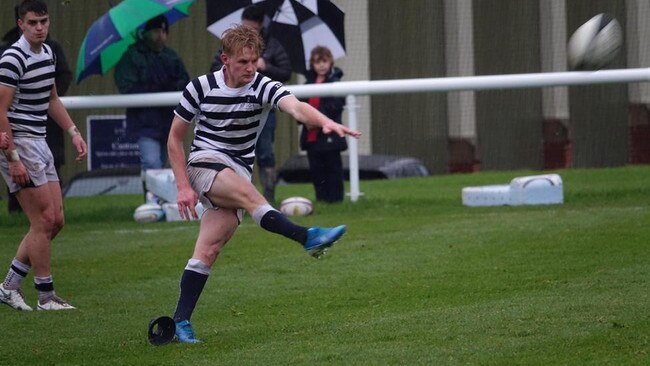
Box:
[115,15,190,202]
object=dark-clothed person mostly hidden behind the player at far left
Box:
[0,5,72,212]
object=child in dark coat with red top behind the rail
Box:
[300,46,348,202]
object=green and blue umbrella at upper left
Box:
[75,0,195,83]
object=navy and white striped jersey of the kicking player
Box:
[174,70,291,172]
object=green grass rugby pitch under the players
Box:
[0,167,650,365]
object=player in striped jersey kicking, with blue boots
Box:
[167,25,361,343]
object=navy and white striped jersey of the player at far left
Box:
[0,36,56,138]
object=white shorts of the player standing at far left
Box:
[0,137,59,193]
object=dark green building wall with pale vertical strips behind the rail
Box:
[0,0,650,197]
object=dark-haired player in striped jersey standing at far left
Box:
[0,0,88,311]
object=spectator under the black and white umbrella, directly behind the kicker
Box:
[210,5,291,202]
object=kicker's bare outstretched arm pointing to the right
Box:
[279,95,361,138]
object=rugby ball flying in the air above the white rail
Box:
[567,14,623,70]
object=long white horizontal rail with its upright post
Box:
[61,68,650,202]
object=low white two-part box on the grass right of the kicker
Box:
[462,174,564,207]
